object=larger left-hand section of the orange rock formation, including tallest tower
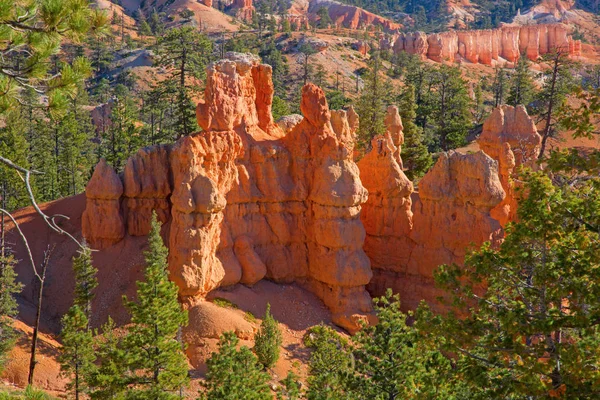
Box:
[84,53,372,330]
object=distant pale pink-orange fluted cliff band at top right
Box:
[392,24,581,65]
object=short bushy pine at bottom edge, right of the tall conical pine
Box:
[200,332,273,400]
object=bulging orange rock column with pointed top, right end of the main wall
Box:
[286,84,372,331]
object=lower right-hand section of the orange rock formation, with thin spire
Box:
[358,106,541,309]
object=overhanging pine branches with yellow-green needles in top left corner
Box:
[0,0,107,113]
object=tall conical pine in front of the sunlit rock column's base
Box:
[123,213,188,399]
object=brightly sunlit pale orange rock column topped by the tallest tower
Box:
[169,60,246,296]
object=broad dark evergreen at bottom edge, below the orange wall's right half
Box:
[350,289,453,400]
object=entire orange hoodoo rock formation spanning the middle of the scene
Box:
[82,53,540,331]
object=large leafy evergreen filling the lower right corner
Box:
[431,166,600,399]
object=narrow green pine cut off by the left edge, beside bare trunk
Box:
[0,255,22,372]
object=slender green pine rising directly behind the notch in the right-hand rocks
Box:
[398,85,433,181]
